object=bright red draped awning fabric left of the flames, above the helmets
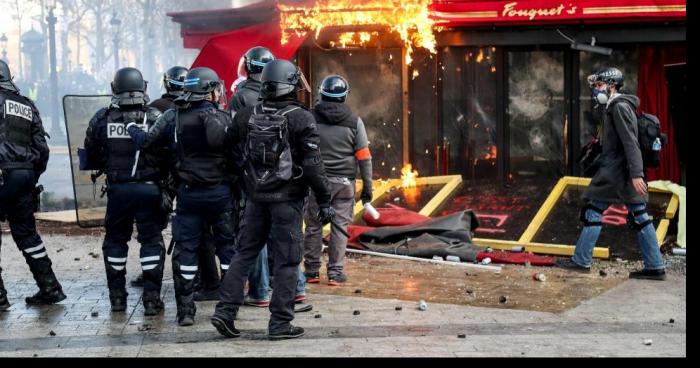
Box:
[192,19,304,97]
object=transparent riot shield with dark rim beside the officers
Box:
[63,95,112,227]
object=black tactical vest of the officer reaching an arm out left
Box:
[175,109,226,185]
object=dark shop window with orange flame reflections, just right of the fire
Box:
[438,47,500,180]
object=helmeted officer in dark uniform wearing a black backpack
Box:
[211,60,332,339]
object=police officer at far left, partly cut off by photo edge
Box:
[0,60,66,310]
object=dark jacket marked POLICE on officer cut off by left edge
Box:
[0,87,49,180]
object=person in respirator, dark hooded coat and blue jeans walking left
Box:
[560,68,666,280]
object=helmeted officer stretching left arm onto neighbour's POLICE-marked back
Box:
[128,68,239,326]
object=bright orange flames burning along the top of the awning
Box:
[278,0,441,64]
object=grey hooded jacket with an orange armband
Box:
[313,101,372,183]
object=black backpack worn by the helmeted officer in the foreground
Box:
[244,104,300,192]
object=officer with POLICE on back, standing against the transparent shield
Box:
[85,68,168,316]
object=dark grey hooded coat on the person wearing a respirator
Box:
[584,94,649,204]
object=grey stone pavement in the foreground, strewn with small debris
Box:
[0,234,686,357]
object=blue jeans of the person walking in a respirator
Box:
[571,201,664,270]
